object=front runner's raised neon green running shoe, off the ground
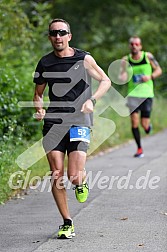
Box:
[74,182,89,203]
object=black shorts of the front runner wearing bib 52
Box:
[43,124,89,154]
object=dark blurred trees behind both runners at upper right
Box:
[52,0,167,95]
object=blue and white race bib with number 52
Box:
[70,126,90,143]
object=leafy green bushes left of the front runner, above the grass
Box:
[0,0,49,138]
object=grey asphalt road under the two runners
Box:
[0,130,167,252]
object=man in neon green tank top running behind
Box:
[120,36,162,157]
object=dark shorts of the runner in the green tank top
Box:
[127,97,153,118]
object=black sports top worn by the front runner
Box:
[34,48,92,126]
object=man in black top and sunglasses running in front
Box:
[34,19,111,238]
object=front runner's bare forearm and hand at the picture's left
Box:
[33,83,46,121]
